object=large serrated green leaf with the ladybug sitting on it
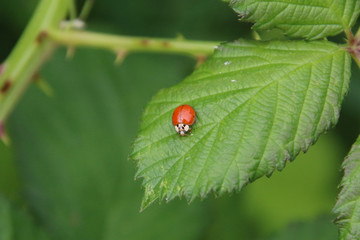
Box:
[131,40,350,207]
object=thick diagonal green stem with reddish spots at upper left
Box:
[0,0,70,124]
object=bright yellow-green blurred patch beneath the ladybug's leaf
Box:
[243,134,343,236]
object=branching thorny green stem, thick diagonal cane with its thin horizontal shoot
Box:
[0,0,218,142]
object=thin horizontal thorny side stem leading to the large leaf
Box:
[46,30,219,56]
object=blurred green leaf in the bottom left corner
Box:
[0,195,48,240]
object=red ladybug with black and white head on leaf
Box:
[173,105,195,136]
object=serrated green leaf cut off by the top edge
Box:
[230,0,360,39]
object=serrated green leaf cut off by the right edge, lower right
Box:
[334,137,360,239]
